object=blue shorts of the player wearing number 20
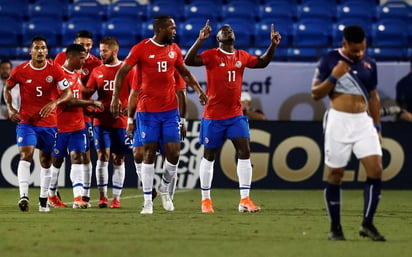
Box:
[93,126,131,154]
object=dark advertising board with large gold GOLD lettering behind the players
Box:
[0,120,412,189]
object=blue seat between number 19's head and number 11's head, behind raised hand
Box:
[178,18,217,47]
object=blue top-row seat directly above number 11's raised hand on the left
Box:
[184,1,222,23]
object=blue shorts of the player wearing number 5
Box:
[16,123,57,153]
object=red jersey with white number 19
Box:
[125,38,183,112]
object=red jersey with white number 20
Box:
[87,62,135,128]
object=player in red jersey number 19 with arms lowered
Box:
[110,15,207,214]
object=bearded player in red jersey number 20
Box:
[87,37,134,208]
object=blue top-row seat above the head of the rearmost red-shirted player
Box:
[67,1,107,21]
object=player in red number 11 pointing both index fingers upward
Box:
[185,20,281,213]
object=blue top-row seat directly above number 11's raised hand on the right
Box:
[259,1,297,19]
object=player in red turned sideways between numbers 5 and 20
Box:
[48,44,103,208]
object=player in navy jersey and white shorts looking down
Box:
[312,25,385,241]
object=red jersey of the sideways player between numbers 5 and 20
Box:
[57,67,86,133]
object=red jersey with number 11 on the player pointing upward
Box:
[200,48,258,120]
